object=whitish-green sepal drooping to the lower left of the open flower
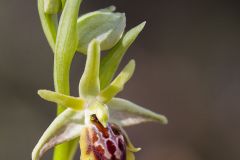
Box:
[32,109,84,160]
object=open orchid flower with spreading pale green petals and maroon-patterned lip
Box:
[32,39,167,160]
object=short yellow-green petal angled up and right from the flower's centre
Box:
[99,60,135,103]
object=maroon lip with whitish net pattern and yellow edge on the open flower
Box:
[80,115,126,160]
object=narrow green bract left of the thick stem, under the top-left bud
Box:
[38,0,58,51]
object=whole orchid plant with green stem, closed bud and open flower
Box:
[32,0,167,160]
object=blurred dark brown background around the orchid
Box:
[0,0,240,160]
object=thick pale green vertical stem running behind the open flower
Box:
[53,0,82,160]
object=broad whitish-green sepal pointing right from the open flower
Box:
[108,98,168,126]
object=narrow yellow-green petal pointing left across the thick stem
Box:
[38,90,85,110]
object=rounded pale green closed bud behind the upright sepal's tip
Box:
[78,7,126,54]
